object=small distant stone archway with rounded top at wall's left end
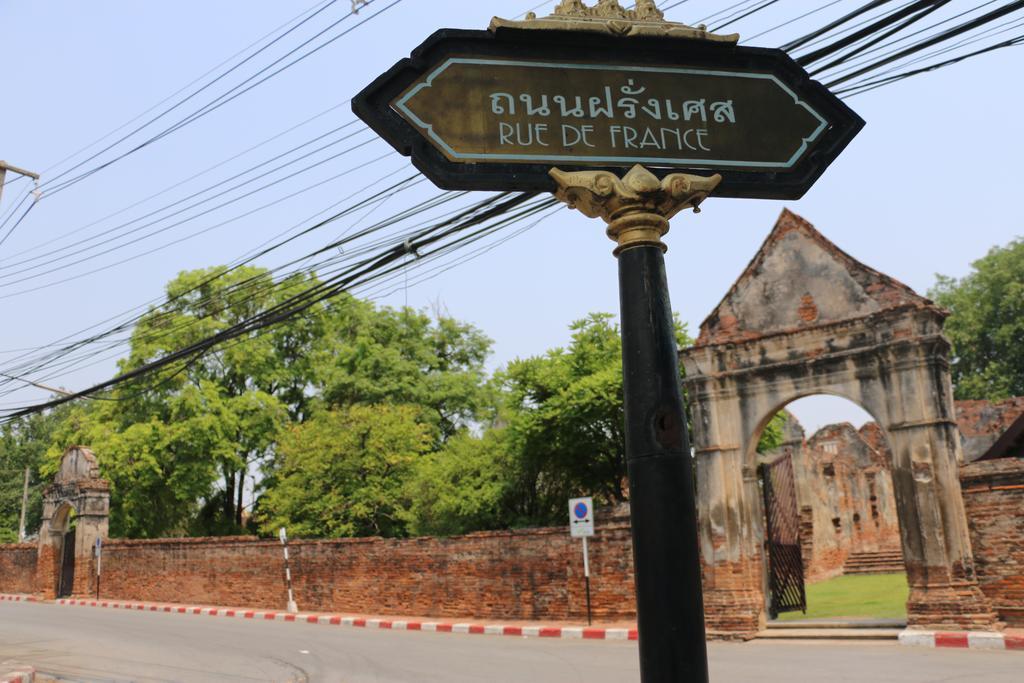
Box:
[36,446,111,600]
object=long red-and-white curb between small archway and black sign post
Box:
[34,599,637,640]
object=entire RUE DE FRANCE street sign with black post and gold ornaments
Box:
[352,0,864,683]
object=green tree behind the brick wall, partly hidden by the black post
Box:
[410,313,783,535]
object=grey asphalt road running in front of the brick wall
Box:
[0,602,1024,683]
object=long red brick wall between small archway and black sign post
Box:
[90,525,635,620]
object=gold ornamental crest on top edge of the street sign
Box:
[490,0,739,44]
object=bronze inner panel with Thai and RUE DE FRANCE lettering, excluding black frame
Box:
[392,57,827,170]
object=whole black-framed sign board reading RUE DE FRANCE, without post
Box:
[352,28,864,199]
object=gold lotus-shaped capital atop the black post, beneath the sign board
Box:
[549,164,722,256]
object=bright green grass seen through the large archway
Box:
[778,573,910,622]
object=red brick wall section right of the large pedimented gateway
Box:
[961,458,1024,628]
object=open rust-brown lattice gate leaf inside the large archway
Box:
[761,456,807,618]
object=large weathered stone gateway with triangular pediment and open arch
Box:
[682,211,996,634]
